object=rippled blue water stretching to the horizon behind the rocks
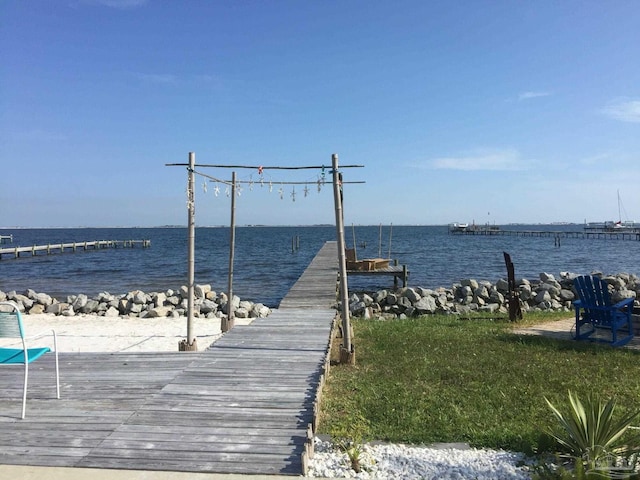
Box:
[0,225,640,306]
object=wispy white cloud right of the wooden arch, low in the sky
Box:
[430,149,525,171]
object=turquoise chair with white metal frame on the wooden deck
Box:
[0,302,60,418]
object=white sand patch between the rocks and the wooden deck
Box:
[0,314,251,352]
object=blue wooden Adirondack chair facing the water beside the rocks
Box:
[573,275,633,347]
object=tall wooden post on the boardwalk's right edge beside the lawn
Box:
[331,153,355,364]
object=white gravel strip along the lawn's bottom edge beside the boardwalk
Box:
[308,439,531,480]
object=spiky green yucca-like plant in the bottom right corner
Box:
[545,391,640,478]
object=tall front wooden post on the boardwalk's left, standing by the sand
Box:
[178,152,198,352]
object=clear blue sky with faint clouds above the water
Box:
[0,0,640,227]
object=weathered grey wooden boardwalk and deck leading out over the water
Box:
[0,242,337,475]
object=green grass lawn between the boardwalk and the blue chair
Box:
[320,314,640,454]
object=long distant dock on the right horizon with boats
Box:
[449,225,640,241]
